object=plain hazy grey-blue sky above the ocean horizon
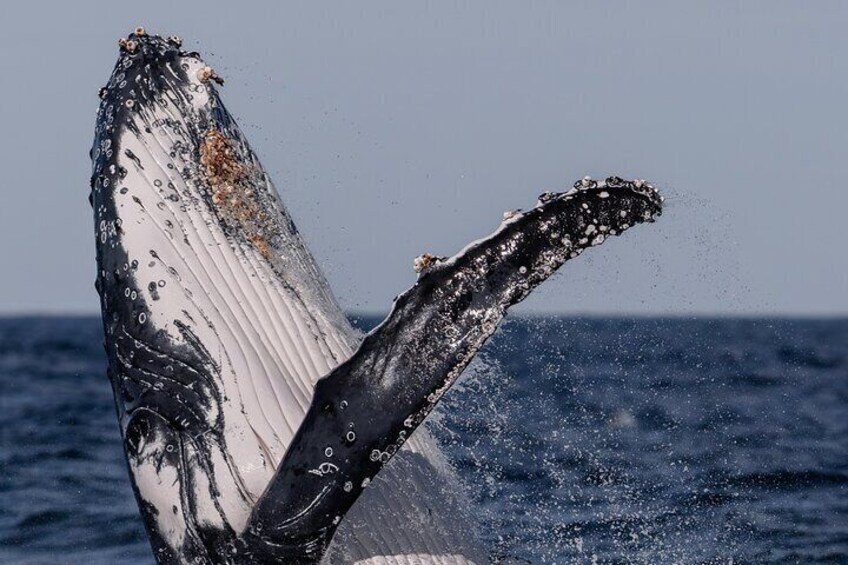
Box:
[0,0,848,314]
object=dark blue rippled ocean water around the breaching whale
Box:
[0,318,848,564]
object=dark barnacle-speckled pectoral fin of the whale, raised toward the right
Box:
[244,177,662,562]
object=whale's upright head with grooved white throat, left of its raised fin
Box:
[90,28,357,561]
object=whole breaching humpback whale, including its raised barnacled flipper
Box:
[90,28,662,564]
